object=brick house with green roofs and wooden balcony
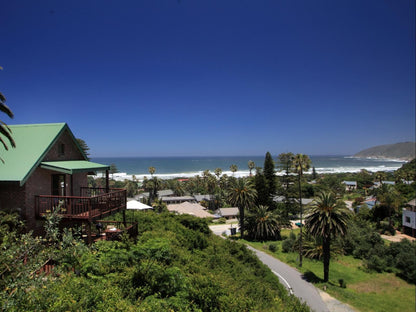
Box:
[0,123,127,236]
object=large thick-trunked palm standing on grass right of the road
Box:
[305,192,351,282]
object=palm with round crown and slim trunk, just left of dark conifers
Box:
[228,179,257,238]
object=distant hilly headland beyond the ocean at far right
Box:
[354,142,416,161]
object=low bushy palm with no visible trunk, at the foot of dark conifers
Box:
[245,205,281,241]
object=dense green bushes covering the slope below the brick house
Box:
[0,212,308,311]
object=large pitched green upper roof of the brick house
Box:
[0,123,87,185]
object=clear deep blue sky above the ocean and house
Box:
[0,0,415,156]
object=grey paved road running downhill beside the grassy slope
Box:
[210,224,355,312]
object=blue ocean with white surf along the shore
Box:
[91,156,405,180]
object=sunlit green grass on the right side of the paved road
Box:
[245,229,416,312]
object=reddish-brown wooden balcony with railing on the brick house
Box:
[35,188,127,221]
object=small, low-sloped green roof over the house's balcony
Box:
[40,160,110,174]
